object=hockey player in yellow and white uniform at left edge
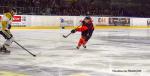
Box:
[0,9,16,53]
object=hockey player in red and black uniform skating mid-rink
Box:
[71,17,94,49]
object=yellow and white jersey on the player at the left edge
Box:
[1,13,13,30]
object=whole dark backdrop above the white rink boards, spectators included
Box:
[0,0,150,17]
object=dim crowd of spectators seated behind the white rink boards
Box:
[0,0,147,17]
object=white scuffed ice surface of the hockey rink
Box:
[0,29,150,76]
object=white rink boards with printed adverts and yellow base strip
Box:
[0,15,150,29]
